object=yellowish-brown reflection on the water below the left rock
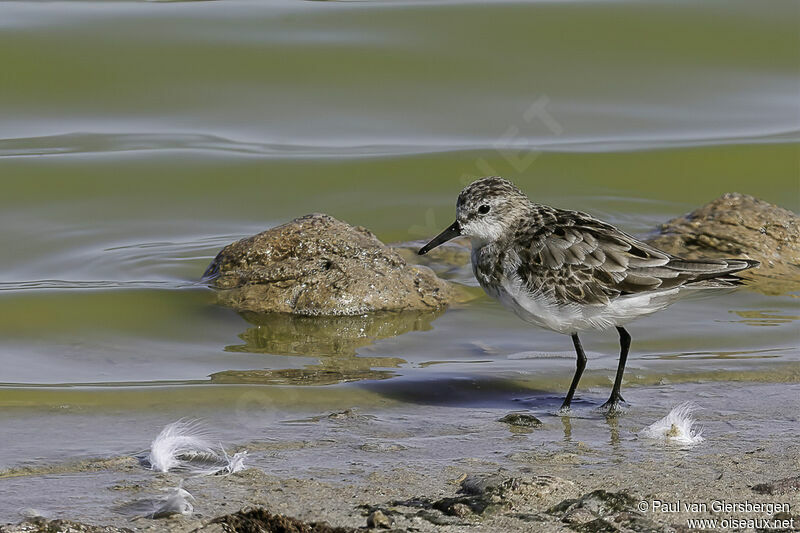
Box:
[210,310,443,385]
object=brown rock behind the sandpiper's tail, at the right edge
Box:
[648,193,800,293]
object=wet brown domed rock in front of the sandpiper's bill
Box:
[203,213,454,316]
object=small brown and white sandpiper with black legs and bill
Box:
[419,176,759,413]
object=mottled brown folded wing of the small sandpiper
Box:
[516,210,752,304]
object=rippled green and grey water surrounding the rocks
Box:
[0,0,800,520]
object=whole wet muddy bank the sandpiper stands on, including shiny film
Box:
[0,382,800,533]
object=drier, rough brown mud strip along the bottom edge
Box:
[0,447,800,533]
